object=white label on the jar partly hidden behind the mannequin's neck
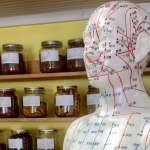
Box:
[87,94,100,105]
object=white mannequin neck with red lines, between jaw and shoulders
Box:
[100,70,150,116]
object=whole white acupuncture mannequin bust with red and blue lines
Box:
[63,1,150,150]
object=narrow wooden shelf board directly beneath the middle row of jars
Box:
[0,117,78,122]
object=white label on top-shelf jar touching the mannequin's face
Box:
[67,47,84,60]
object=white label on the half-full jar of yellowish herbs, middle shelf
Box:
[23,96,40,106]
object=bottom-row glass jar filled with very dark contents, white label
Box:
[8,130,33,150]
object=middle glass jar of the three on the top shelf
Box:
[40,41,66,73]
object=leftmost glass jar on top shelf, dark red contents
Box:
[1,44,25,75]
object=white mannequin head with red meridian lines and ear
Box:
[83,1,150,88]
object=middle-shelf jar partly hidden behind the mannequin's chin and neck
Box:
[86,85,100,115]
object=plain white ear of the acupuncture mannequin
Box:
[135,33,150,63]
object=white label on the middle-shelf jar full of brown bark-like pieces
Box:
[56,95,74,106]
